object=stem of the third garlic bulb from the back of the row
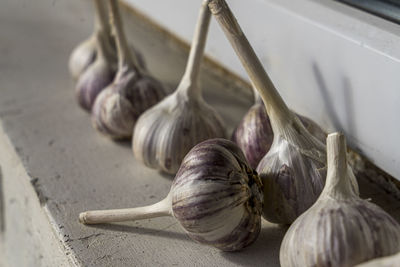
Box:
[109,0,141,73]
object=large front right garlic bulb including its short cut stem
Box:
[280,133,400,267]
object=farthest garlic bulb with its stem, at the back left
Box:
[68,0,110,80]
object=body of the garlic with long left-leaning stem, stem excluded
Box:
[257,135,326,224]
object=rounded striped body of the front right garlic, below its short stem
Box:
[280,199,400,267]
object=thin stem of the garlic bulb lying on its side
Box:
[79,194,172,224]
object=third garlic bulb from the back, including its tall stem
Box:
[92,0,166,139]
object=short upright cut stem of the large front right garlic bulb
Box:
[321,133,357,200]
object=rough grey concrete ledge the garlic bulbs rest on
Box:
[0,0,400,266]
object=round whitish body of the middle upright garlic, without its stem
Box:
[132,92,225,174]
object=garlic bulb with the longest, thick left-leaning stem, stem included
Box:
[209,0,358,224]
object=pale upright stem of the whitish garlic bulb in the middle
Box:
[178,0,211,97]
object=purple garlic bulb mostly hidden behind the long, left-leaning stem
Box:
[232,90,326,168]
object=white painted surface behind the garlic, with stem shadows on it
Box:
[125,0,400,179]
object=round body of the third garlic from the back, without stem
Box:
[92,68,166,139]
